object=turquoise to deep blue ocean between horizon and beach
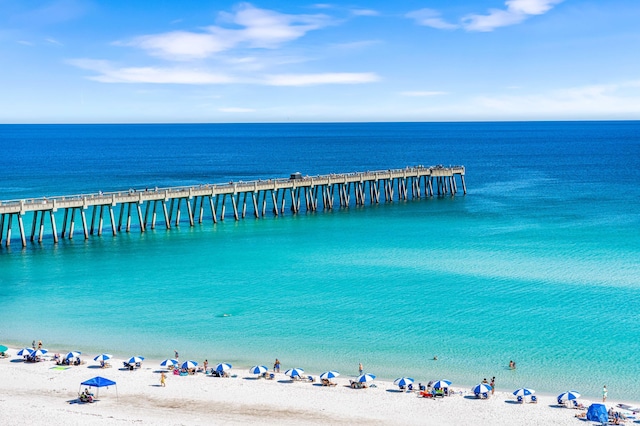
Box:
[0,121,640,401]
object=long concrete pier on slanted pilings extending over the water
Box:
[0,166,467,247]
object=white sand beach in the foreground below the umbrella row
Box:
[0,349,638,426]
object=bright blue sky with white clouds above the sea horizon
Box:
[0,0,640,123]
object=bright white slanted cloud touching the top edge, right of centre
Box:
[462,0,563,32]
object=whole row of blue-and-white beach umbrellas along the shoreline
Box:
[11,348,580,404]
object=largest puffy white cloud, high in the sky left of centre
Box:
[125,3,332,61]
